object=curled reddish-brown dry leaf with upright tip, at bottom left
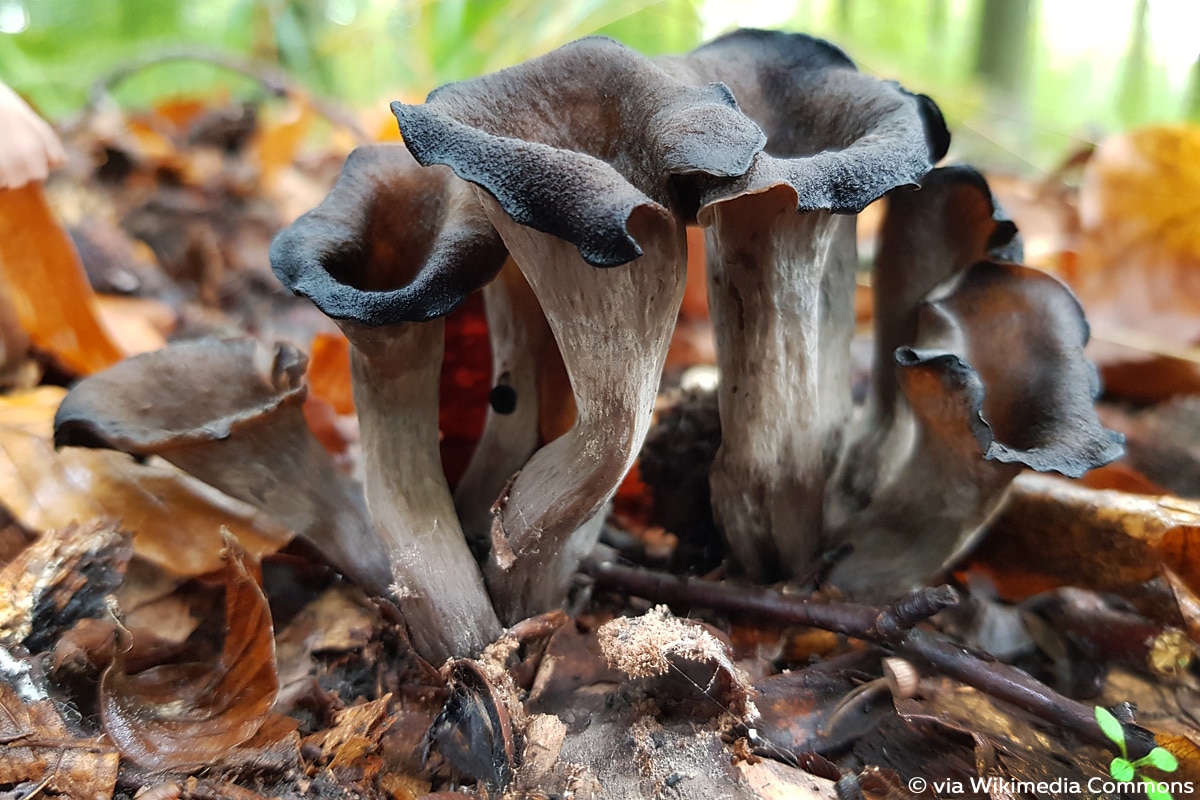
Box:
[100,539,285,770]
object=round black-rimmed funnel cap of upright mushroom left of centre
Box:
[271,144,508,325]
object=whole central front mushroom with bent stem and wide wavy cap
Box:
[392,38,763,622]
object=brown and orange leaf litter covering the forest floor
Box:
[0,48,1200,799]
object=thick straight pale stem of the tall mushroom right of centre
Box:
[708,186,856,579]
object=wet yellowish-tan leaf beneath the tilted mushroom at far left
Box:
[0,386,292,576]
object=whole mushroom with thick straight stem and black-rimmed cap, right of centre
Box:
[670,30,948,579]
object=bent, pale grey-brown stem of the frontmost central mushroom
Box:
[480,200,686,624]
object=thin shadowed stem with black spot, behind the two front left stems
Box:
[454,259,558,554]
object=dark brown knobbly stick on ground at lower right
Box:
[584,563,1154,758]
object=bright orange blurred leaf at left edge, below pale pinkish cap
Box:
[0,184,125,374]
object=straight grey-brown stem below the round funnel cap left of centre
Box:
[342,318,500,663]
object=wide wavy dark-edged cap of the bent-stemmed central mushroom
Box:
[392,37,766,266]
